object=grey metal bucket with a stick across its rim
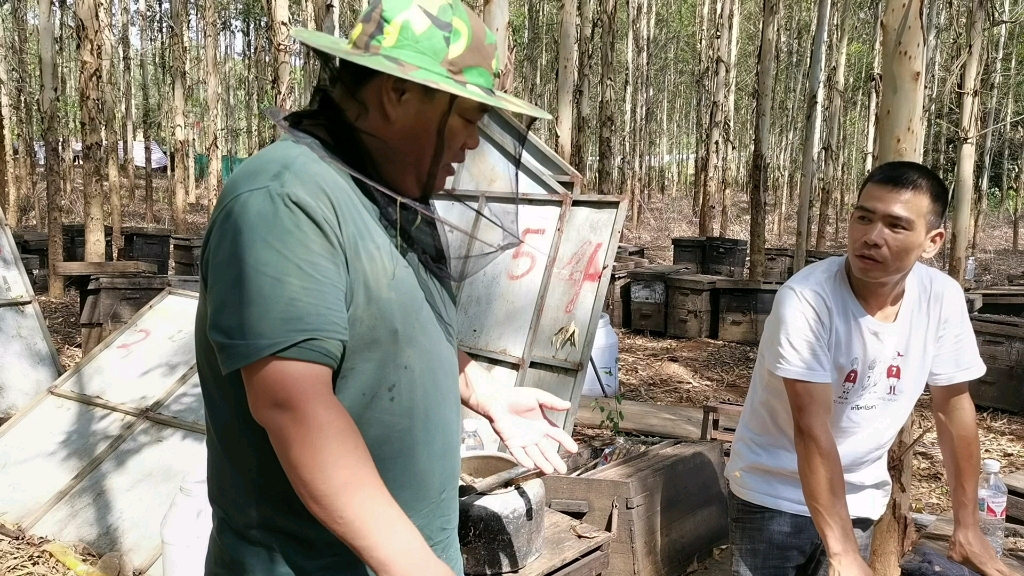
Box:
[459,452,547,576]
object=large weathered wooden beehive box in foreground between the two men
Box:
[544,440,729,576]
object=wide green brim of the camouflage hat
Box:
[291,28,552,120]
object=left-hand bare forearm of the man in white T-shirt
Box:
[794,425,860,559]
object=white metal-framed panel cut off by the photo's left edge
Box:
[0,206,61,421]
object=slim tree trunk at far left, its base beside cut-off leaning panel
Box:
[39,0,63,298]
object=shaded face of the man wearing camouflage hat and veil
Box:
[372,80,489,200]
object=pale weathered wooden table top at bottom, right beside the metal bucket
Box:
[509,508,611,576]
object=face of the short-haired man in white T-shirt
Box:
[848,183,945,282]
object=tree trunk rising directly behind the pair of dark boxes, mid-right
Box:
[698,0,733,236]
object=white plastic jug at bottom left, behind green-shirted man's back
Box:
[160,458,213,576]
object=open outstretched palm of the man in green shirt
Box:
[487,387,579,474]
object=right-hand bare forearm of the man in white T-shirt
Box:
[932,384,981,527]
